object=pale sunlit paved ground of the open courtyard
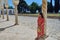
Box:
[0,15,60,40]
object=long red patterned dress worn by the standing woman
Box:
[37,16,44,38]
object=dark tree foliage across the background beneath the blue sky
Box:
[17,0,59,13]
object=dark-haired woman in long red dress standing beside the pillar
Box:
[35,13,44,40]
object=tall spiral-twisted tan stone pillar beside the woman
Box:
[42,0,47,35]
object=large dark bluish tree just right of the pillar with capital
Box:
[18,0,28,13]
